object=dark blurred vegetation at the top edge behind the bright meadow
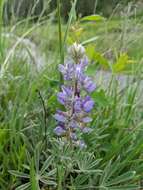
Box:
[1,0,137,21]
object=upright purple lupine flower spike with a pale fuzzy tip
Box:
[54,43,96,147]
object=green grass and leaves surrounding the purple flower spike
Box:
[0,1,143,190]
